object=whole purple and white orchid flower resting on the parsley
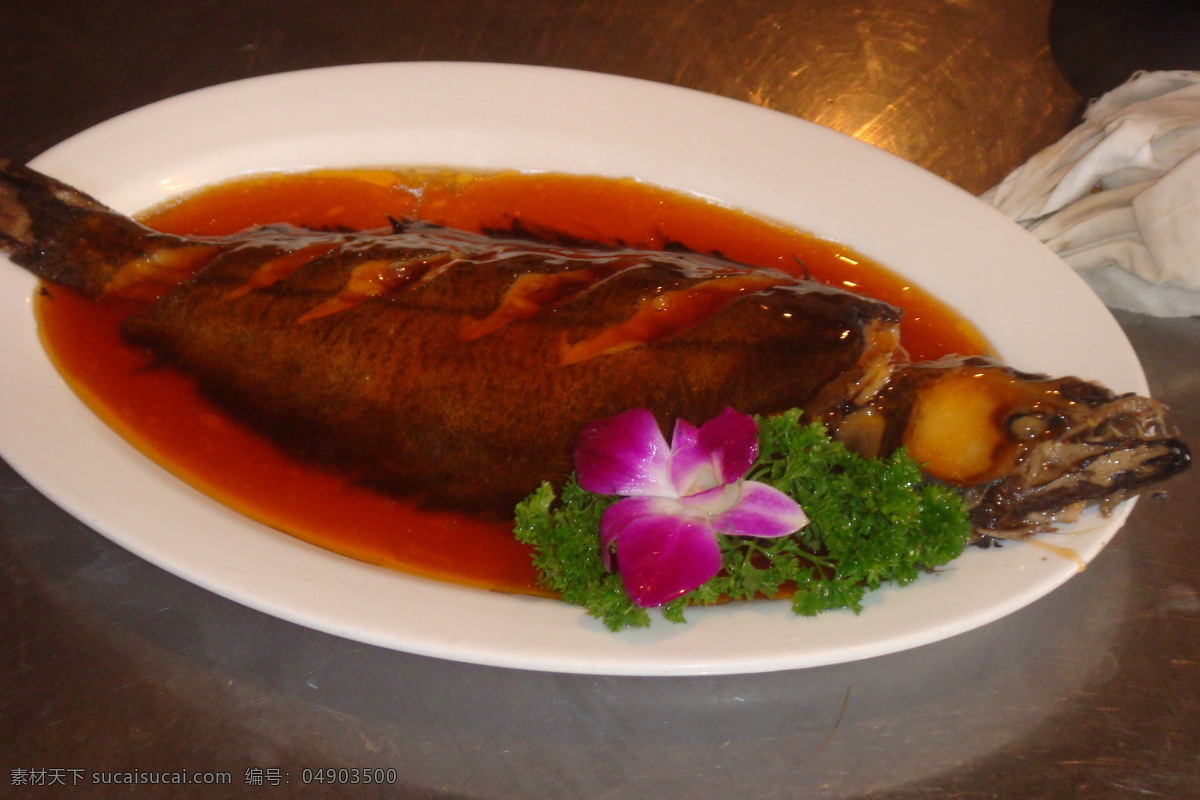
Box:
[575,408,809,607]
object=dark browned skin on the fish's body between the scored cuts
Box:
[125,221,896,513]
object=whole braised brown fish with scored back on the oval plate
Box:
[0,163,1189,535]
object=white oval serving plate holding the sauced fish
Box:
[0,64,1147,675]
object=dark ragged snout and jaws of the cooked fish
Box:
[965,393,1192,539]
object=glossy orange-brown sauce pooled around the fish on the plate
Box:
[36,169,986,594]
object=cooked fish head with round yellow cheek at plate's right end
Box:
[836,357,1190,537]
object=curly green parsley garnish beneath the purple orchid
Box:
[514,410,972,631]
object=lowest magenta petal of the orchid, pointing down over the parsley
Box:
[601,498,721,607]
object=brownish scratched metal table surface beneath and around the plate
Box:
[0,0,1200,799]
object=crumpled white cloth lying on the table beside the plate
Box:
[983,71,1200,317]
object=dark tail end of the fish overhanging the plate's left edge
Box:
[0,160,204,296]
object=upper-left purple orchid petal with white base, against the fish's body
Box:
[575,408,674,497]
